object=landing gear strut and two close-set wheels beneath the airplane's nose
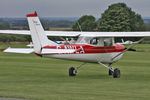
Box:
[98,62,120,78]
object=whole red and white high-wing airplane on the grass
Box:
[0,12,150,78]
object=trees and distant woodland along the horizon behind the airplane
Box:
[0,3,150,42]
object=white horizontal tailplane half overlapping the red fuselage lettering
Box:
[41,49,76,54]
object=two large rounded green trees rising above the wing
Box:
[72,3,146,32]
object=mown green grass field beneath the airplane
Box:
[0,45,150,100]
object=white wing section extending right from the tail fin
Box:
[45,31,150,37]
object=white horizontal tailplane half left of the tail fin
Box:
[3,47,34,54]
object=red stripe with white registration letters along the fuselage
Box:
[43,44,125,53]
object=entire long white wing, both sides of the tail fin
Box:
[0,30,150,37]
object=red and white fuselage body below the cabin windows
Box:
[36,44,125,63]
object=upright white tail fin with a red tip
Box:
[27,11,57,53]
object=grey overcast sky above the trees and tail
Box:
[0,0,150,17]
